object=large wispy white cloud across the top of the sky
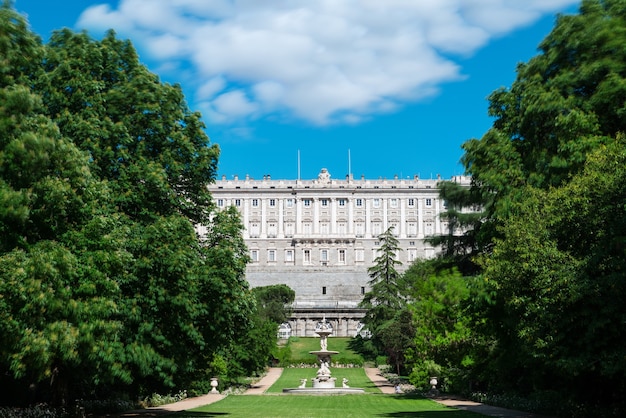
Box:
[78,0,578,124]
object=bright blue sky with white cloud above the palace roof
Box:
[15,0,578,179]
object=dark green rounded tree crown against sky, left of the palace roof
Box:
[36,29,219,223]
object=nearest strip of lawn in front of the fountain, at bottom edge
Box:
[176,393,484,418]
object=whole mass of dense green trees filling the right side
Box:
[356,0,626,416]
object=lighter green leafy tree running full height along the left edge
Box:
[0,2,129,403]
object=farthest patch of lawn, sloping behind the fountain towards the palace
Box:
[289,337,363,365]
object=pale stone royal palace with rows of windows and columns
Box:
[209,169,469,336]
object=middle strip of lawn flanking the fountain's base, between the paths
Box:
[267,367,380,393]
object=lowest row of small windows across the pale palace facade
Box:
[250,248,417,265]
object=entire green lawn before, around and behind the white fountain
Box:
[175,337,483,418]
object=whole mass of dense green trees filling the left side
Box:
[0,2,266,404]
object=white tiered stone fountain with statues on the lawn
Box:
[283,316,365,394]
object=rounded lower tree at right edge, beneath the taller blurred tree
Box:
[478,140,626,403]
